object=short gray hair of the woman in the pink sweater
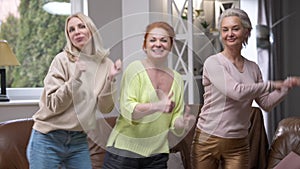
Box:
[218,8,252,45]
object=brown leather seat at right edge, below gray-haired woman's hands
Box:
[268,117,300,169]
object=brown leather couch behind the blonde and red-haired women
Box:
[0,105,200,169]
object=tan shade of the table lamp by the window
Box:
[0,40,20,66]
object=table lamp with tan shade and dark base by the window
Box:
[0,40,20,102]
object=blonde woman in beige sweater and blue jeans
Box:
[27,13,121,169]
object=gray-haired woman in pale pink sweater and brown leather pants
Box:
[191,9,297,169]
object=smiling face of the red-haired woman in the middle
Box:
[144,28,172,58]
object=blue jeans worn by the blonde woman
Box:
[27,130,92,169]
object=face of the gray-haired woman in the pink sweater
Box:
[221,16,249,47]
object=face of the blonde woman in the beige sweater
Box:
[67,17,91,50]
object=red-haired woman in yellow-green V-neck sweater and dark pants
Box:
[103,22,195,169]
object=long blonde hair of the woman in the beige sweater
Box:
[64,12,109,62]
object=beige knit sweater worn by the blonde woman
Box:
[33,52,114,133]
